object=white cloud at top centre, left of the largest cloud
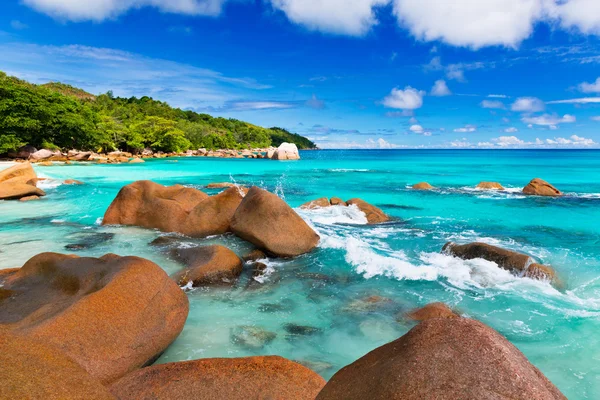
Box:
[270,0,390,36]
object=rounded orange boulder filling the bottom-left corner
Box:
[0,331,115,400]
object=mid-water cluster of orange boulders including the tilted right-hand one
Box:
[102,181,319,257]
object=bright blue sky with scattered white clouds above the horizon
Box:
[0,0,600,149]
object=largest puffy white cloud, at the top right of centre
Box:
[394,0,543,48]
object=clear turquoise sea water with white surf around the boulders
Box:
[0,150,600,399]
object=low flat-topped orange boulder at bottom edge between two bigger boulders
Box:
[110,356,325,400]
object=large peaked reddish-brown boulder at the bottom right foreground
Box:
[317,318,566,400]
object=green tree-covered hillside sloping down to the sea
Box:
[0,72,316,154]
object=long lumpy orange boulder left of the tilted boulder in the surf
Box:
[102,181,244,237]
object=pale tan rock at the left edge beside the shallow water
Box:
[0,162,46,200]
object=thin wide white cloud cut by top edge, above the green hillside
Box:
[23,0,226,21]
